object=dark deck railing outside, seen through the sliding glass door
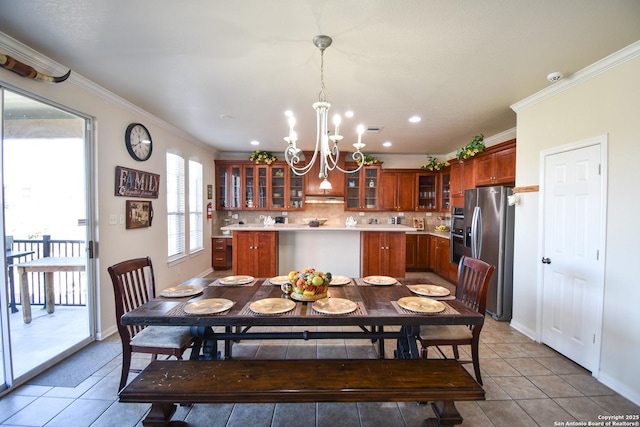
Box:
[7,235,87,306]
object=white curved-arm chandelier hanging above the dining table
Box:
[284,35,365,190]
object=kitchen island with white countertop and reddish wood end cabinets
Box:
[222,224,415,277]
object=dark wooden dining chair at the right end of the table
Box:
[418,256,495,385]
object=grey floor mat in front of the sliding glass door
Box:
[28,341,122,387]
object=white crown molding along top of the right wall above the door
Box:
[511,40,640,113]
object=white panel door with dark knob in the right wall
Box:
[542,144,604,372]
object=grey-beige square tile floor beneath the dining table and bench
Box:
[0,273,640,427]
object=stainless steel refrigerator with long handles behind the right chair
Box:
[464,187,515,321]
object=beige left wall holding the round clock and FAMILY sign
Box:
[0,33,215,338]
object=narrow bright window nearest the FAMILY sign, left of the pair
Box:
[166,153,186,261]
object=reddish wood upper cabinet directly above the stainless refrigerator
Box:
[475,140,516,186]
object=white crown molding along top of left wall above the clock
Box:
[0,32,210,151]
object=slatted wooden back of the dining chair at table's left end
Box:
[108,257,155,342]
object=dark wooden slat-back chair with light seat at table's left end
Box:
[107,257,194,390]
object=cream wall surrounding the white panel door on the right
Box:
[512,43,640,404]
